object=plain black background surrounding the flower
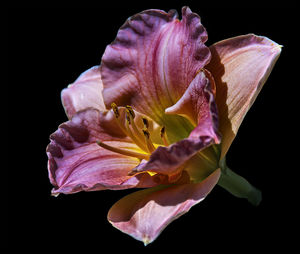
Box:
[5,1,299,253]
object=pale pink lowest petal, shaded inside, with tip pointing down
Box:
[107,169,220,245]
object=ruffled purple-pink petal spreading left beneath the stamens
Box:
[47,108,157,194]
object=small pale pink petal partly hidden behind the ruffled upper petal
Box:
[61,66,105,119]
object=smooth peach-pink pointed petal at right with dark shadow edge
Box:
[206,34,281,157]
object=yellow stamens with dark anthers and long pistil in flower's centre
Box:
[97,103,168,160]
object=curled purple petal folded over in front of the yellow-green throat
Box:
[132,72,220,179]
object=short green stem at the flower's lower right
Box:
[218,163,262,206]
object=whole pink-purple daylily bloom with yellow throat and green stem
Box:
[47,7,281,244]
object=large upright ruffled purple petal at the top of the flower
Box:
[101,7,210,124]
